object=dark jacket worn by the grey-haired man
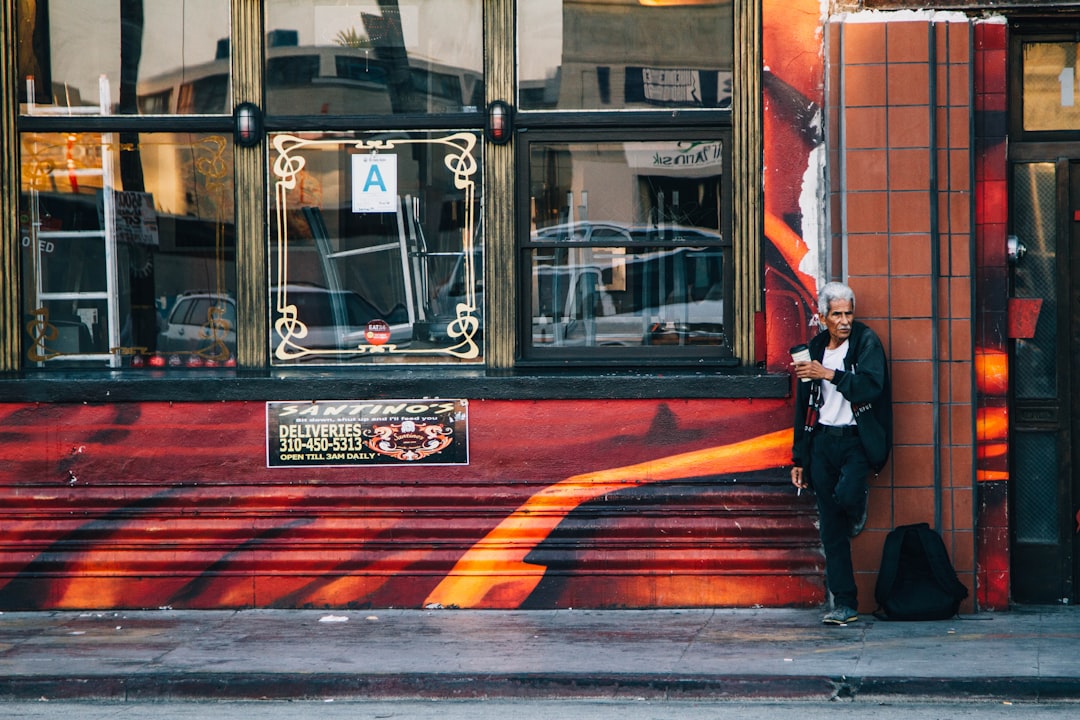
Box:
[792,321,892,472]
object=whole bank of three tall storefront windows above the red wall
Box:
[8,0,745,379]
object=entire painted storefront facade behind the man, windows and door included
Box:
[0,0,1080,610]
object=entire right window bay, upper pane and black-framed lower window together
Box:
[516,0,734,364]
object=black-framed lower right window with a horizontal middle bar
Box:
[523,138,731,359]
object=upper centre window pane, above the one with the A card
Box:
[266,0,484,116]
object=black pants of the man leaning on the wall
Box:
[810,431,870,610]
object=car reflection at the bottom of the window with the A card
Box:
[270,284,413,350]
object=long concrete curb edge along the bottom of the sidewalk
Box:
[0,673,1080,703]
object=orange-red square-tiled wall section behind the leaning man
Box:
[827,15,982,611]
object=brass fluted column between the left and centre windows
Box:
[229,0,264,370]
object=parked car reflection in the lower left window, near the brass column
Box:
[158,291,237,355]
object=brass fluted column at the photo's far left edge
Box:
[0,2,23,372]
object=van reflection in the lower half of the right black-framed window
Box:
[532,247,725,347]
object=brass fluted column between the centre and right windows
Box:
[482,2,517,369]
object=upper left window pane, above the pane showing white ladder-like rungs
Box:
[18,0,232,116]
